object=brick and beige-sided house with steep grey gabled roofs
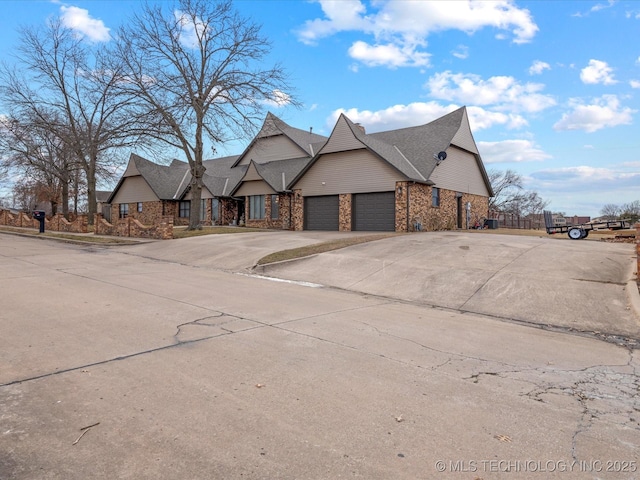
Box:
[109,107,493,232]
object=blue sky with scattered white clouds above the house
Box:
[0,0,640,217]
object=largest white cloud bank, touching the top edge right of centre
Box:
[296,0,538,68]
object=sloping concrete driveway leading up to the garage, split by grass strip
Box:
[181,232,640,341]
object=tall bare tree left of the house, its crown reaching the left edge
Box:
[0,19,144,223]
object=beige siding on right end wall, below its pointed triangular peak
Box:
[429,147,489,196]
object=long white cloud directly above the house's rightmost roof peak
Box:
[425,71,556,112]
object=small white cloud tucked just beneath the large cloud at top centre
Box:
[349,41,430,68]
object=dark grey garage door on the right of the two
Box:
[352,192,396,232]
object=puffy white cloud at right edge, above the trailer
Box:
[553,95,636,133]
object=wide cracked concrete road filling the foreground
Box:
[0,231,640,480]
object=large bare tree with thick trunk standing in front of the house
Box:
[112,0,296,229]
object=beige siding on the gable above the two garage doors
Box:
[294,149,406,196]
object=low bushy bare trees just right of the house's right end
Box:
[488,170,549,216]
